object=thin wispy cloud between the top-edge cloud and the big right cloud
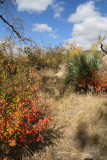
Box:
[52,2,64,18]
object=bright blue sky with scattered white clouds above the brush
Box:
[0,0,107,49]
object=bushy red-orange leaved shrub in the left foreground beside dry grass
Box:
[0,68,51,146]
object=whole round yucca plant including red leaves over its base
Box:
[66,53,102,92]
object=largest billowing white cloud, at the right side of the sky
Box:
[68,1,107,49]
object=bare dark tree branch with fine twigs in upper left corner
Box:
[0,0,31,41]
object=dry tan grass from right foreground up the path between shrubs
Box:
[24,71,107,160]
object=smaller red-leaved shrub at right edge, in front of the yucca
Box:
[77,68,107,94]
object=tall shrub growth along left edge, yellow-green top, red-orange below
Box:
[0,43,51,151]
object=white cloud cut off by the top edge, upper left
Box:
[16,0,53,12]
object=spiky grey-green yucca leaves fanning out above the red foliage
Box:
[66,53,102,90]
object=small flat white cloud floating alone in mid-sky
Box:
[32,23,58,39]
